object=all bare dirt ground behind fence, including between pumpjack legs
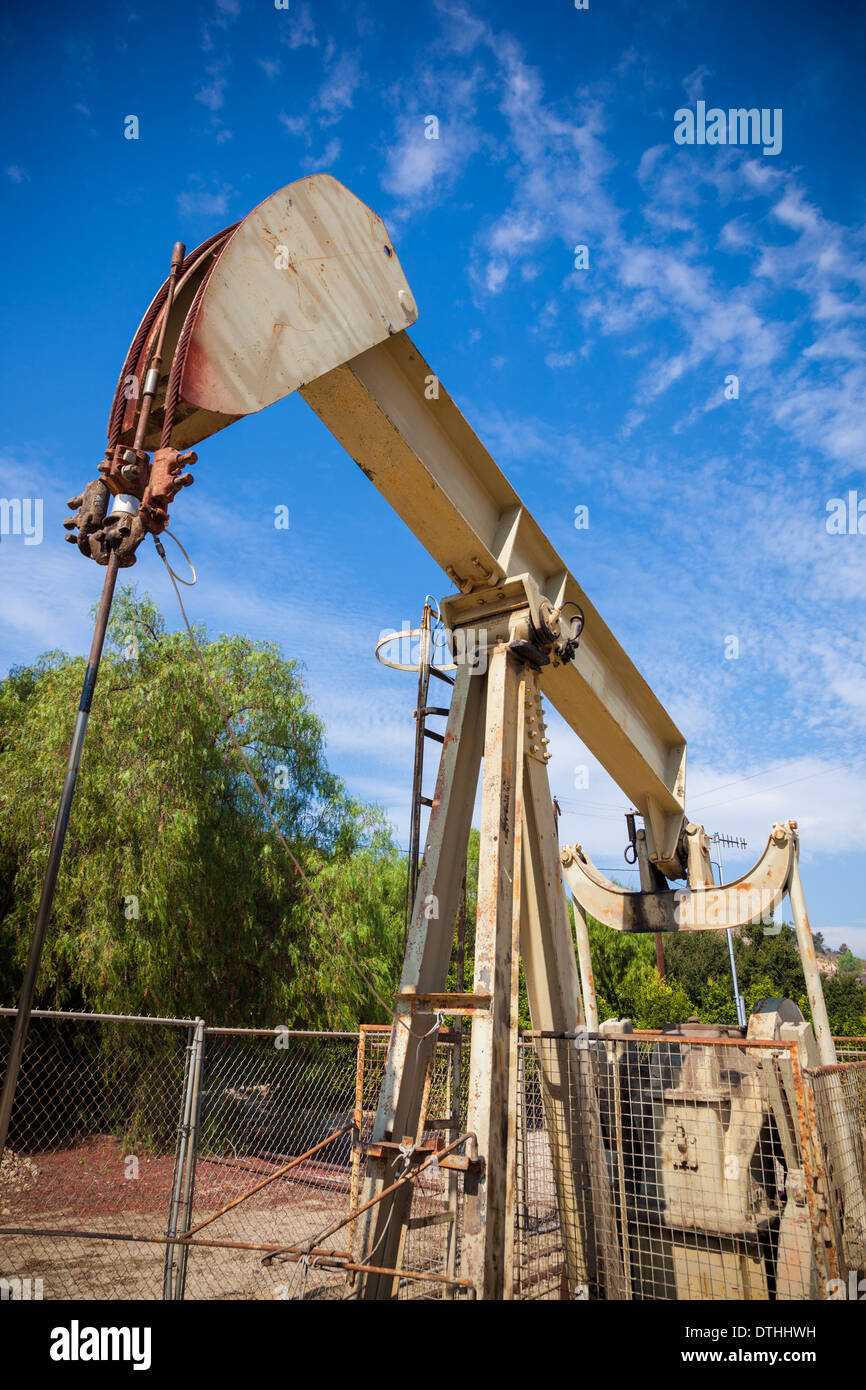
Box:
[0,1136,562,1300]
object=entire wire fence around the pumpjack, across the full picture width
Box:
[0,1009,866,1300]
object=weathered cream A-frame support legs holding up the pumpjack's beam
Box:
[349,591,621,1300]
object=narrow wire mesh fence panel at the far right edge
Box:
[806,1059,866,1297]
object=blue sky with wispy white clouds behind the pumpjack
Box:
[0,0,866,955]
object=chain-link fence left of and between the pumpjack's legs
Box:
[0,1009,475,1300]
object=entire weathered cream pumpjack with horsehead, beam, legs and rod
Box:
[6,174,853,1300]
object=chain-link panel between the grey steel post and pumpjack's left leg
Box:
[185,1029,357,1300]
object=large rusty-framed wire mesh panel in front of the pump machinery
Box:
[518,1034,822,1300]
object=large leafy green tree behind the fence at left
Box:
[0,589,405,1027]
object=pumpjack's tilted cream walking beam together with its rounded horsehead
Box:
[122,174,685,877]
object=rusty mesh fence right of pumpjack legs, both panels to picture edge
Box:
[517,1029,866,1301]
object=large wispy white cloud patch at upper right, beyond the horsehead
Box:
[397,14,866,478]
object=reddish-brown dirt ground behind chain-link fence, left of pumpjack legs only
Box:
[0,1138,358,1298]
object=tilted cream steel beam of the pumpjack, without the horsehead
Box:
[300,332,685,862]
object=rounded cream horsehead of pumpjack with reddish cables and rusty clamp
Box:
[64,174,417,569]
